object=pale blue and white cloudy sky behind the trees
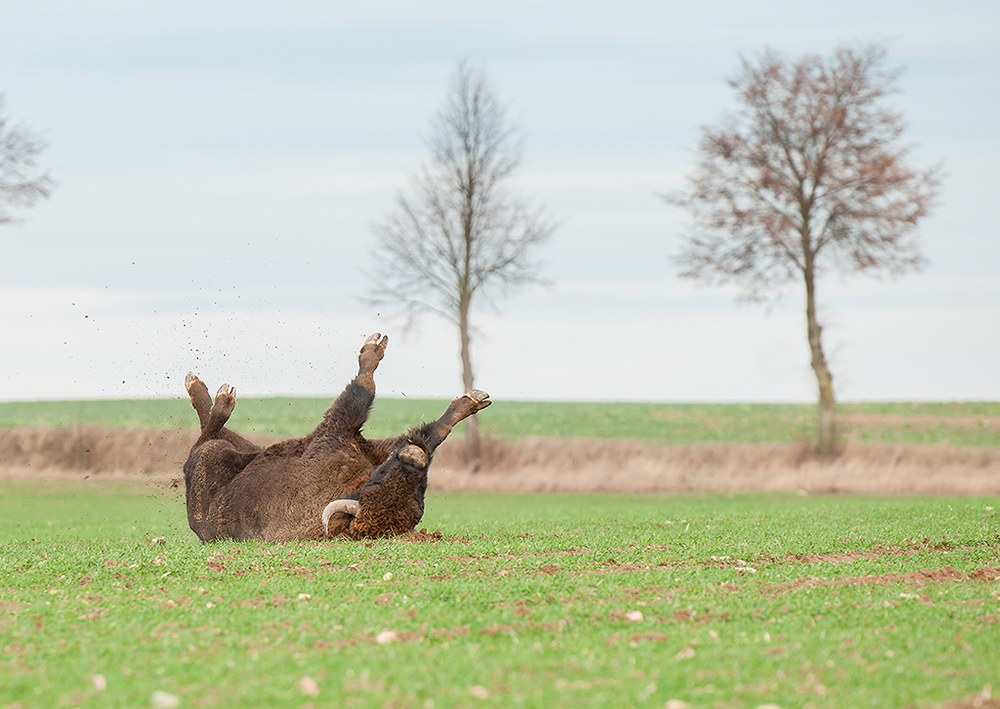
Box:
[0,0,1000,401]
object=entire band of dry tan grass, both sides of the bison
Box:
[0,426,1000,495]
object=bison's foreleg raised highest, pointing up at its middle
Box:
[305,332,389,457]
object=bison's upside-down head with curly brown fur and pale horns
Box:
[323,443,431,539]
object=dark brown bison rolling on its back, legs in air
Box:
[184,333,491,542]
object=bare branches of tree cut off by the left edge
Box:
[0,95,53,226]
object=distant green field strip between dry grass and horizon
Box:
[0,398,1000,446]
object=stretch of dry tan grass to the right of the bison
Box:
[430,438,1000,495]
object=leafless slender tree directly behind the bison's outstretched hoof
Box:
[370,63,554,462]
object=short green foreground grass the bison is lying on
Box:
[0,483,1000,709]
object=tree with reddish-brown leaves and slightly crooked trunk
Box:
[664,44,940,456]
